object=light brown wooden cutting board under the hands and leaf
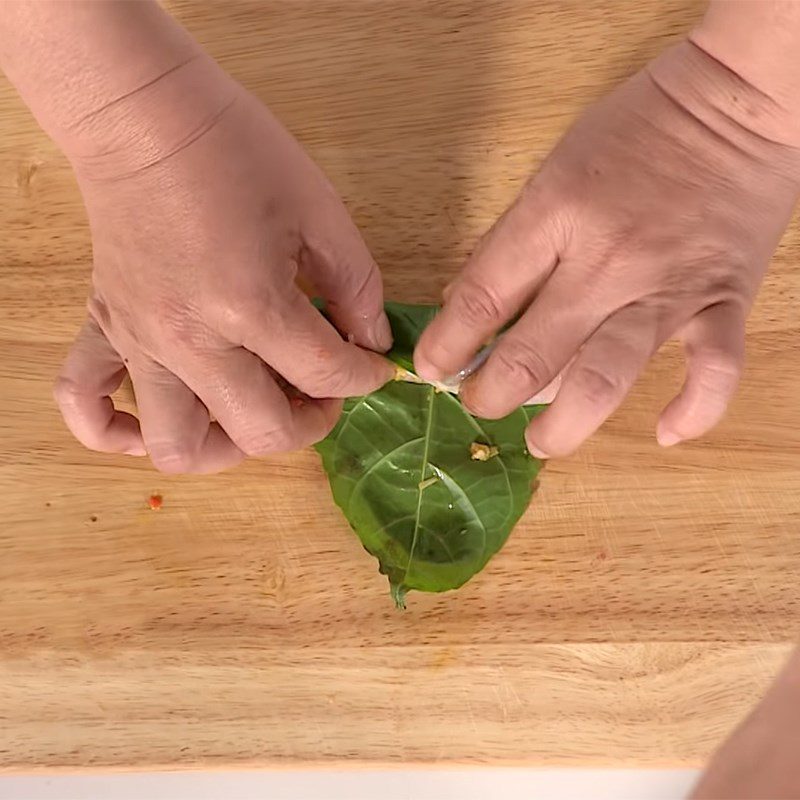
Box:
[0,0,800,771]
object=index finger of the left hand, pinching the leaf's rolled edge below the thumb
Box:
[231,286,394,398]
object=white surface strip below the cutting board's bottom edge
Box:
[0,768,698,800]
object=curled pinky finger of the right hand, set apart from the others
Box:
[656,303,745,447]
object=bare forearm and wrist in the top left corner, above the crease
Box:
[0,0,241,177]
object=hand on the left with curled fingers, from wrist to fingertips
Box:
[55,67,392,472]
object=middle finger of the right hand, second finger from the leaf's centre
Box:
[461,267,608,419]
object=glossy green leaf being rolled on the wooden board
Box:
[317,303,542,606]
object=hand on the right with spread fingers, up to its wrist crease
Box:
[415,42,800,457]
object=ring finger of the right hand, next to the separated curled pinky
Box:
[525,305,666,458]
